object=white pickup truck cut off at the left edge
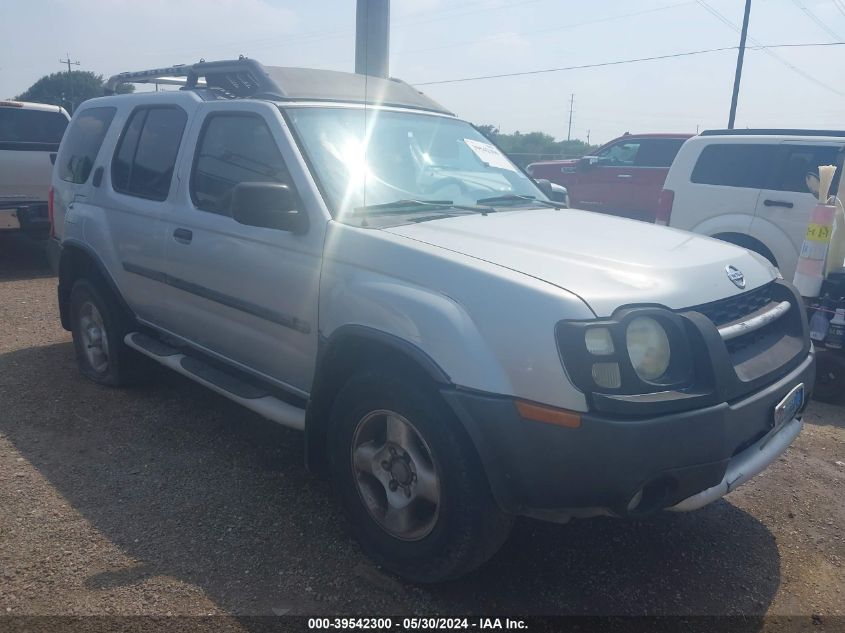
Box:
[0,101,70,238]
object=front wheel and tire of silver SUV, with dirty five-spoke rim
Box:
[328,370,513,583]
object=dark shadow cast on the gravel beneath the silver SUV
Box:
[0,343,780,616]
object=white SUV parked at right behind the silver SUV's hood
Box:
[657,130,845,280]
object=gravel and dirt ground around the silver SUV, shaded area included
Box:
[0,237,845,622]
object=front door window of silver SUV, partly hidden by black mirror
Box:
[191,113,293,215]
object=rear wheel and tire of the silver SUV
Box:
[70,279,144,386]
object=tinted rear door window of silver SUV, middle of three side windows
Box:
[112,106,188,200]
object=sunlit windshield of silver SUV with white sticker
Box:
[286,107,544,218]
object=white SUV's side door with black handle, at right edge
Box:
[750,141,843,280]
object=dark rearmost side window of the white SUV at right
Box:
[691,143,778,189]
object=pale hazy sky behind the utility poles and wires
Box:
[0,0,845,143]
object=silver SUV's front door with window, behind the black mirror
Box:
[166,102,325,395]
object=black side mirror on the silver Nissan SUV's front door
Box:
[229,182,308,234]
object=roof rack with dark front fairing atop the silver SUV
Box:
[105,57,452,115]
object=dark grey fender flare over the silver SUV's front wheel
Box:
[305,325,453,473]
